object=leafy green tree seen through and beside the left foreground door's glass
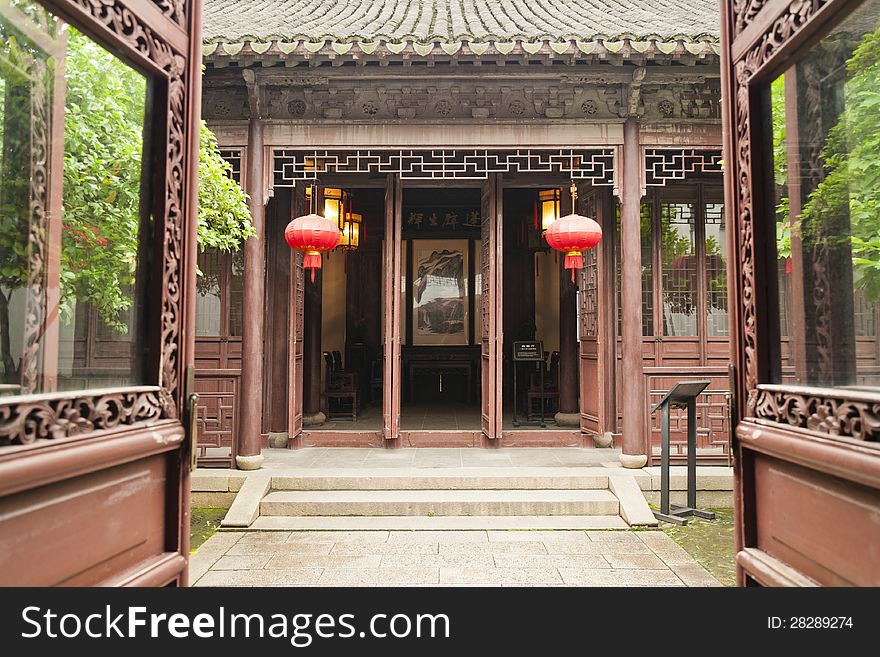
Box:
[0,29,254,376]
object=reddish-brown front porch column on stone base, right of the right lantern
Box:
[620,118,649,468]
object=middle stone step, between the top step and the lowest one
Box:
[260,489,620,516]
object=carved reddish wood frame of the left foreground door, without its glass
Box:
[0,0,202,586]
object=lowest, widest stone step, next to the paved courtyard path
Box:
[244,515,629,531]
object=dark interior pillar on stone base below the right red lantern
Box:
[554,257,581,427]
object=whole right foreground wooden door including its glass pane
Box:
[722,0,880,586]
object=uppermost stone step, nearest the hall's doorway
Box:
[272,468,609,491]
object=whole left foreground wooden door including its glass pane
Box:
[0,0,201,586]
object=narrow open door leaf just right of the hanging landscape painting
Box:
[480,173,504,440]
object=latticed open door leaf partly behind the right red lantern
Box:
[577,187,614,436]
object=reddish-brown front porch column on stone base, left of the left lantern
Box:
[235,119,266,470]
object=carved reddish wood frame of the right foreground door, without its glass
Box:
[722,0,880,586]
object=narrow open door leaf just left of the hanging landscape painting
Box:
[382,174,406,440]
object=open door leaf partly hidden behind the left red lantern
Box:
[287,183,308,445]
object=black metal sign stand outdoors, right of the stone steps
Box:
[651,381,715,525]
